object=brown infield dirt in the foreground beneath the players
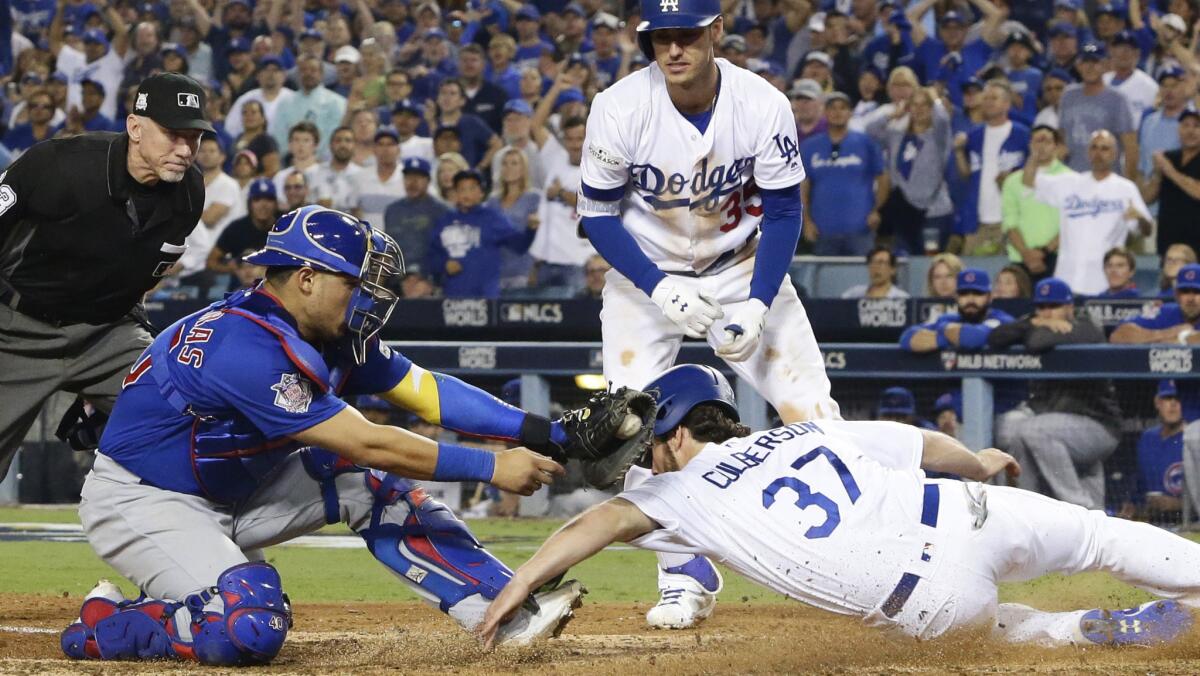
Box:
[0,594,1200,675]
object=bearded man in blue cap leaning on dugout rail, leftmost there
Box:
[900,268,1013,353]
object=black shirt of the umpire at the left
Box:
[0,132,204,324]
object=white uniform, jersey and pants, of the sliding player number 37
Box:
[618,420,1200,645]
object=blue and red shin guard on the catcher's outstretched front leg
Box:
[359,471,512,629]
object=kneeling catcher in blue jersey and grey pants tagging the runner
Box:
[61,207,654,665]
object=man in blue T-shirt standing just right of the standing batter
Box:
[800,91,890,256]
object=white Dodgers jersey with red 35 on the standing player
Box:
[578,59,804,273]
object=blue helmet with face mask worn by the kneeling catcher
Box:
[245,205,404,364]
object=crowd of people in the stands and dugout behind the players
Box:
[0,0,1200,513]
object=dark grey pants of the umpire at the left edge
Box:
[0,305,150,479]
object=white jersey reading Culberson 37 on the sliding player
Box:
[618,420,932,615]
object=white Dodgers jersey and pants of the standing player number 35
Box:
[578,59,839,421]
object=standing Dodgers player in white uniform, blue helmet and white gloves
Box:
[578,0,839,628]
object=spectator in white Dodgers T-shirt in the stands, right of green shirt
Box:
[1021,130,1154,295]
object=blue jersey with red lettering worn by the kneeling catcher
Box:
[100,289,412,503]
